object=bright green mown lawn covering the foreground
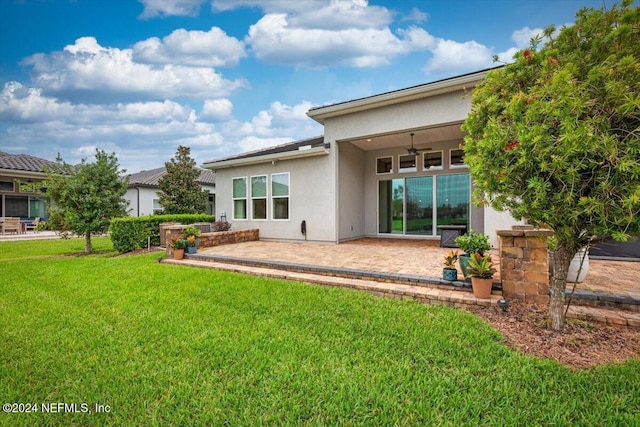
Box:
[0,239,640,426]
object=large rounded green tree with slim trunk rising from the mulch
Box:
[463,0,640,330]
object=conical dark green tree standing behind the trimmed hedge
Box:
[158,145,209,214]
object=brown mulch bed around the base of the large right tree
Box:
[467,301,640,369]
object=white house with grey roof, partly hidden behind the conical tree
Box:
[124,167,216,216]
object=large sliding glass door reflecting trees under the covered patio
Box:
[378,174,470,236]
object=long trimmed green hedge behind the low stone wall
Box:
[111,214,215,253]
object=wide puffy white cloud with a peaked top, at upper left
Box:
[23,37,246,102]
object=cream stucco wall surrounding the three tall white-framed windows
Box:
[216,152,336,242]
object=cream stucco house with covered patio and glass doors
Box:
[203,70,518,246]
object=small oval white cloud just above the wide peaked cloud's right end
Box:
[132,27,246,67]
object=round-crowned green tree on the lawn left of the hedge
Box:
[43,150,128,253]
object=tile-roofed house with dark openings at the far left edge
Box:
[0,151,60,219]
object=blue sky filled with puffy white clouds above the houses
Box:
[0,0,613,173]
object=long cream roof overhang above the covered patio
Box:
[307,70,489,124]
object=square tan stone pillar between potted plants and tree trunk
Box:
[497,225,553,303]
